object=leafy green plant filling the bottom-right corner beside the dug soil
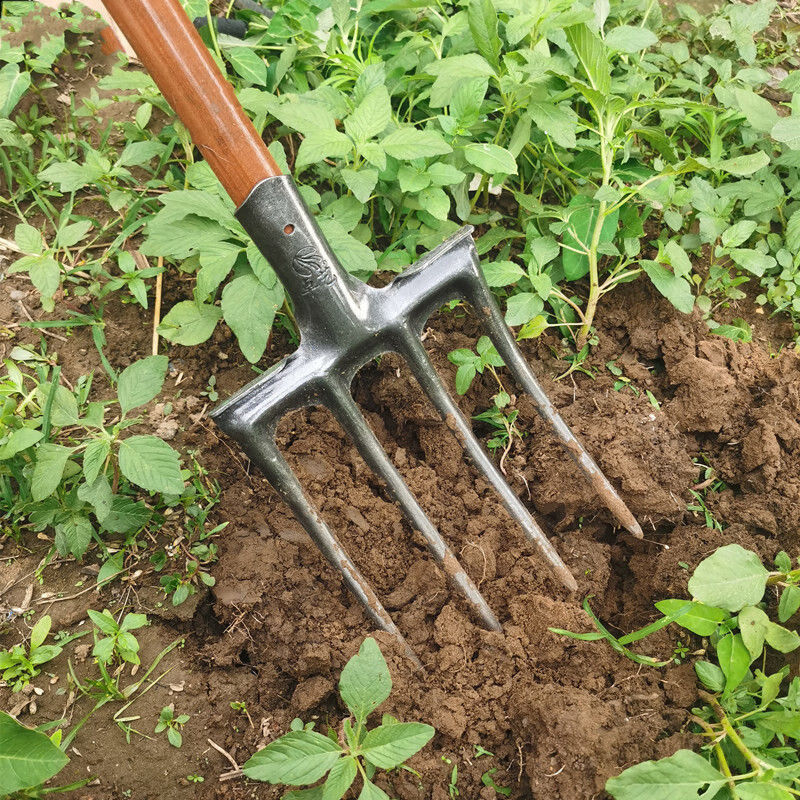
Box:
[581,544,800,800]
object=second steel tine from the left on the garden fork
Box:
[326,387,502,631]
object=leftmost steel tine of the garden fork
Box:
[247,432,422,668]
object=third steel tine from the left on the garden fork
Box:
[400,333,578,592]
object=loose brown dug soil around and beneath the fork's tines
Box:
[0,6,800,800]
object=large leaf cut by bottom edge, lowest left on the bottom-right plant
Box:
[606,750,726,800]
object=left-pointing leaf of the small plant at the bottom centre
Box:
[242,731,342,786]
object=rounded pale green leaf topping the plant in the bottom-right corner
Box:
[689,544,769,612]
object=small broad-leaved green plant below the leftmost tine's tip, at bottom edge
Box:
[242,638,435,800]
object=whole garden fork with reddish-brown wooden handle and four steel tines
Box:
[105,0,642,663]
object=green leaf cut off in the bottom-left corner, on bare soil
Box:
[0,711,69,796]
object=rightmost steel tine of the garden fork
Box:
[473,298,644,539]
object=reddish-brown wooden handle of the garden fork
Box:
[104,0,281,206]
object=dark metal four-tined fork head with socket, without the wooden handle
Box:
[212,176,642,658]
